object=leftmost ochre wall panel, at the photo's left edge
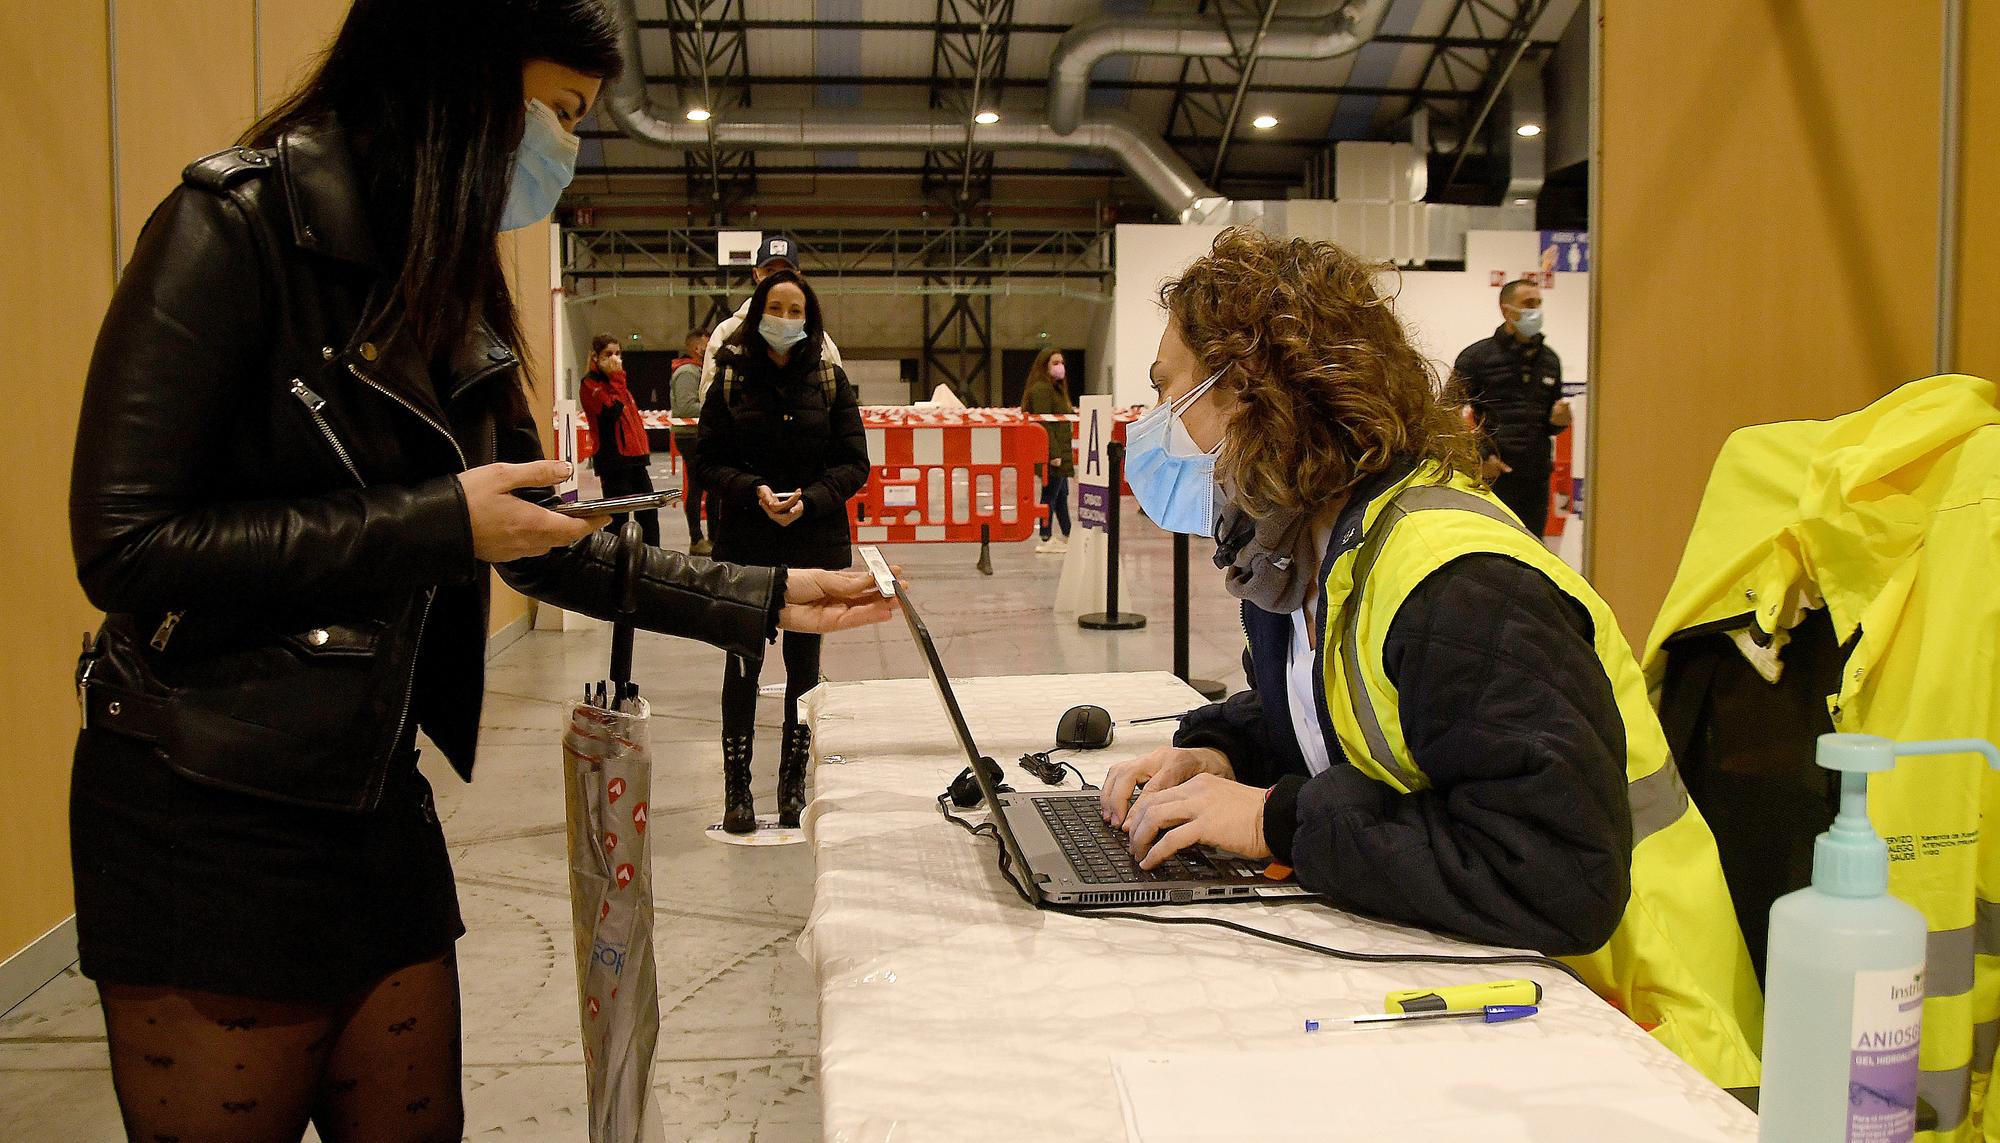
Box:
[0,4,114,959]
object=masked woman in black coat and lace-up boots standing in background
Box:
[700,270,868,833]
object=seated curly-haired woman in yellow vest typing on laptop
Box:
[1102,230,1758,1087]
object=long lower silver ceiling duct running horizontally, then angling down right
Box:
[604,0,1228,222]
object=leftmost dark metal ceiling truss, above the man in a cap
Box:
[648,0,756,226]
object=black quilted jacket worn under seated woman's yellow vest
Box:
[1174,473,1632,955]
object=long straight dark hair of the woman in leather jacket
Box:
[242,0,622,358]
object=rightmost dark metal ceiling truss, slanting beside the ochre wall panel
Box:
[1412,0,1548,188]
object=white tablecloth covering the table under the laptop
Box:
[800,673,1756,1143]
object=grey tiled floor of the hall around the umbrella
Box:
[0,499,1242,1143]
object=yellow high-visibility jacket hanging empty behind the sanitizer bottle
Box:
[1644,374,2000,1143]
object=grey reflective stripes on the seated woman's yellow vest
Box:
[1340,484,1696,847]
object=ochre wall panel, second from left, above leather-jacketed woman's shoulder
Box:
[116,0,256,267]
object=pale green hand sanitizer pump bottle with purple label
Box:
[1758,733,2000,1143]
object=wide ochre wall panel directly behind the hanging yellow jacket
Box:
[1590,0,1944,643]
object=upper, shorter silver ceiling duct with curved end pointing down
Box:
[1048,0,1394,136]
